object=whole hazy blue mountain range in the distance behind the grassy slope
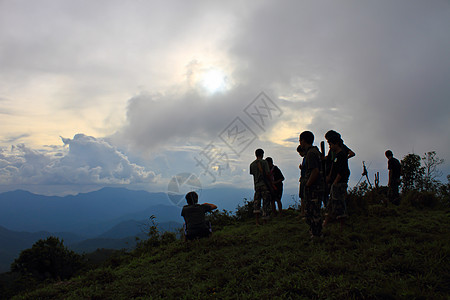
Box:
[0,187,253,272]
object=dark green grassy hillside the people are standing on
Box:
[14,205,450,299]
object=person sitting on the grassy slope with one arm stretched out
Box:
[181,192,217,240]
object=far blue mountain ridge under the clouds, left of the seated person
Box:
[0,188,181,237]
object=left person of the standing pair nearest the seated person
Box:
[250,149,271,225]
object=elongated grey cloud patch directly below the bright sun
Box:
[114,88,272,150]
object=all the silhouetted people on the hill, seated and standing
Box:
[181,130,401,240]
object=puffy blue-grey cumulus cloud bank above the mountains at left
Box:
[0,134,157,186]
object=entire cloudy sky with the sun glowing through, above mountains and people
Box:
[0,0,450,202]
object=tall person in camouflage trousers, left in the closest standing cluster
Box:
[299,131,323,238]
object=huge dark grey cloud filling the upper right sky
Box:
[232,1,450,159]
